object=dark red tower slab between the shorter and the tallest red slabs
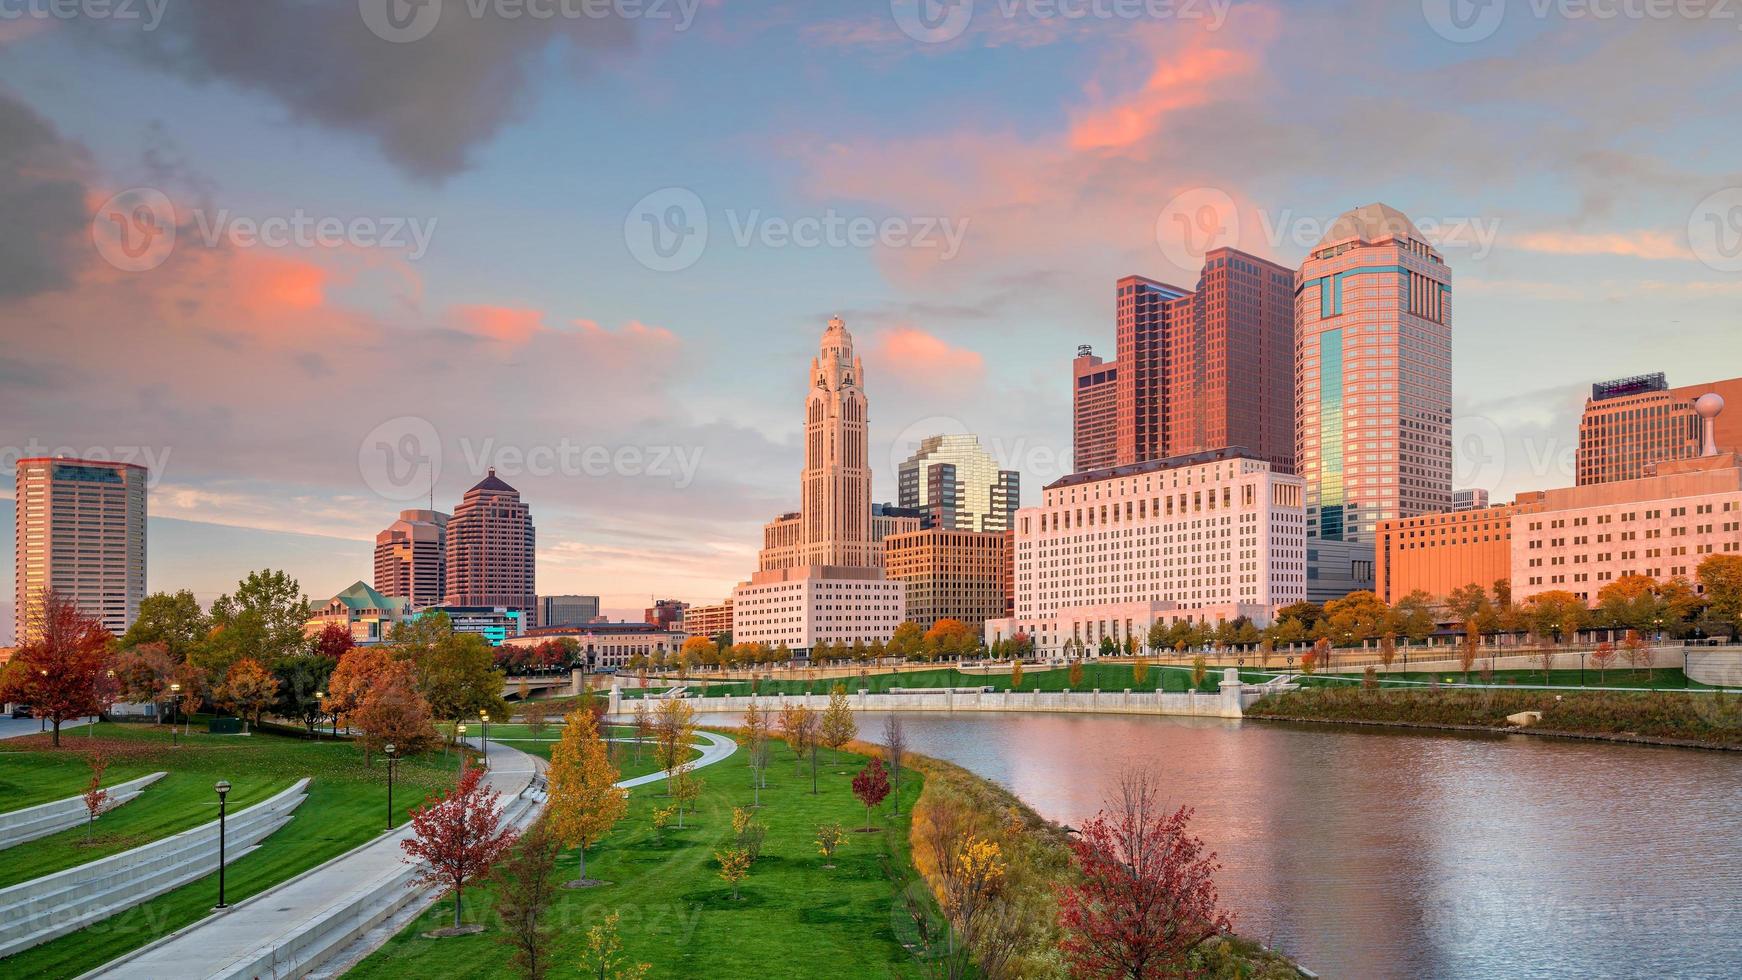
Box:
[1113,275,1186,465]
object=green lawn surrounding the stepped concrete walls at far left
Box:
[0,724,458,977]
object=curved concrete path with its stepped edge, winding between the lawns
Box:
[85,731,739,980]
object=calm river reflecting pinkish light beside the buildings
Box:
[696,712,1742,978]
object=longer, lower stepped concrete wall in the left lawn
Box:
[0,778,308,957]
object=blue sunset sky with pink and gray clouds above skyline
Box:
[0,0,1742,641]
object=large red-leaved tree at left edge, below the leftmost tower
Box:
[0,590,117,748]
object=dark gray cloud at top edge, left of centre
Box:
[73,0,634,179]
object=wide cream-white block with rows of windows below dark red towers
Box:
[986,449,1307,654]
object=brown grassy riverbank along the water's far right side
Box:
[1246,688,1742,750]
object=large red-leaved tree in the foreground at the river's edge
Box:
[1059,775,1233,980]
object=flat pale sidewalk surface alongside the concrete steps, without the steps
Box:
[87,745,538,980]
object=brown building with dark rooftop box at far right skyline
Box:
[1578,373,1742,486]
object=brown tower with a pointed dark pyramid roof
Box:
[442,470,538,625]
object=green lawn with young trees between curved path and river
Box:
[347,745,923,980]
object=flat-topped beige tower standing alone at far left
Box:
[12,456,150,646]
